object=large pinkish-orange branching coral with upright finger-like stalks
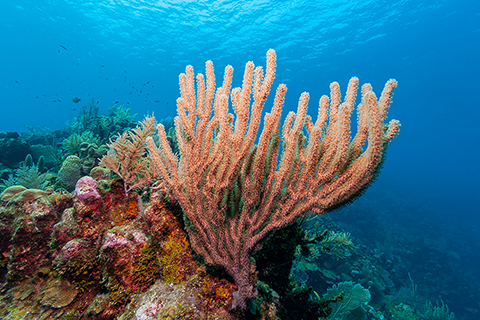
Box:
[147,49,400,309]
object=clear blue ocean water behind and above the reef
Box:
[0,0,480,319]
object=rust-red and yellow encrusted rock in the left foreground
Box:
[0,178,273,320]
